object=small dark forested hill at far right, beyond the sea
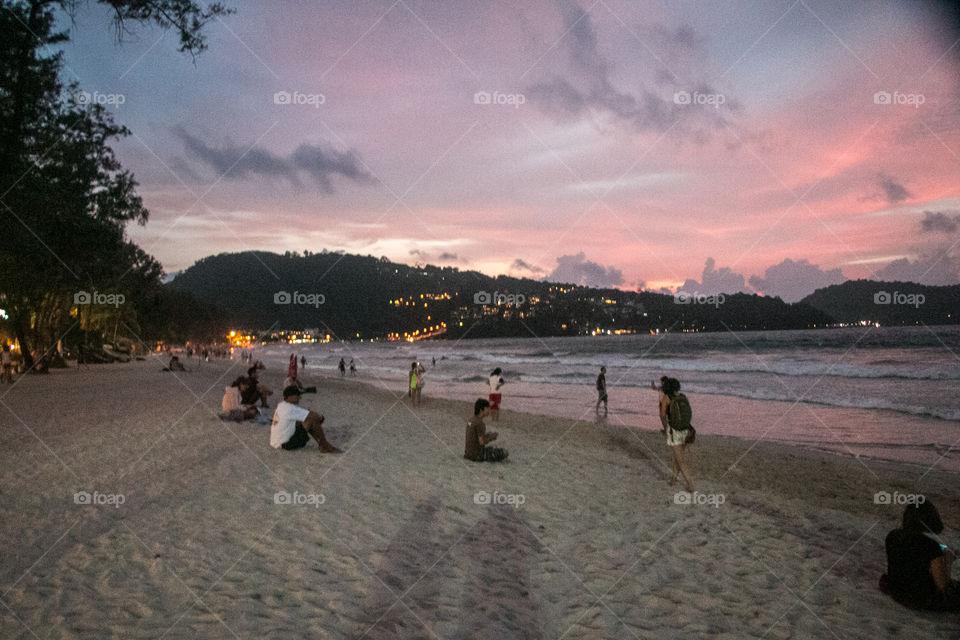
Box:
[801,280,960,326]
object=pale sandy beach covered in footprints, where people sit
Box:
[0,359,960,640]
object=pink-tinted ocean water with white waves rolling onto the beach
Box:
[257,326,960,471]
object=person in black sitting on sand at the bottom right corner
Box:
[881,500,960,613]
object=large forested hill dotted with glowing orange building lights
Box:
[167,251,831,339]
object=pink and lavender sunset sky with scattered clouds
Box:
[66,0,960,299]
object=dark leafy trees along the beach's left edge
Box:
[0,0,228,367]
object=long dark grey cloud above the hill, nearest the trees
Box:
[174,128,372,193]
